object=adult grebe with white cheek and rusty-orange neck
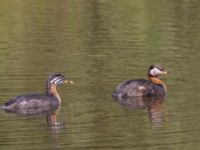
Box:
[112,64,167,99]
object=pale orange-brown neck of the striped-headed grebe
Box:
[46,83,61,104]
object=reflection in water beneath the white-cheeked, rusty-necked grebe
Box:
[115,96,168,127]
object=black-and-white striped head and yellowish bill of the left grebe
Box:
[47,73,73,85]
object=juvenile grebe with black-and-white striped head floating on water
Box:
[1,73,73,112]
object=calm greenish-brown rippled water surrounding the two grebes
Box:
[0,0,200,150]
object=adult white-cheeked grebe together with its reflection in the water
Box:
[112,64,168,125]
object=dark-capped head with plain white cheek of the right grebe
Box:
[148,64,167,77]
